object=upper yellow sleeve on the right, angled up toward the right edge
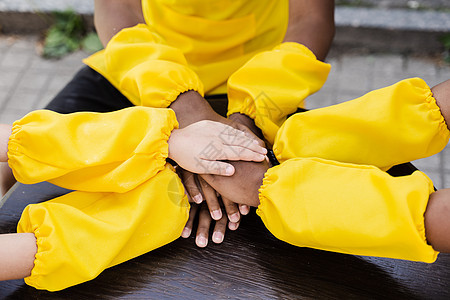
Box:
[273,78,449,170]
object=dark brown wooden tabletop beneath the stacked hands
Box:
[0,179,450,299]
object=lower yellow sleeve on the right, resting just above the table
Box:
[257,158,438,263]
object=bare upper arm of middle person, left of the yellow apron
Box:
[94,0,145,46]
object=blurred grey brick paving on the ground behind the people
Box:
[0,36,450,188]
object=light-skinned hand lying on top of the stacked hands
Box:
[168,120,267,176]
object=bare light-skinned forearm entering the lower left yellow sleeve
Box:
[0,233,37,280]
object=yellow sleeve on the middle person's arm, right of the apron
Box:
[228,42,330,143]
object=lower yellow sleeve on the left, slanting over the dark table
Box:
[17,165,189,291]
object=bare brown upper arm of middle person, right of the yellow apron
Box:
[283,0,335,60]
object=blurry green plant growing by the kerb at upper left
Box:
[42,10,102,58]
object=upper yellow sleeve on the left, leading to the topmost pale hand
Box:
[8,107,178,192]
